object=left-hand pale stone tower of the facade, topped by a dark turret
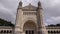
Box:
[14,1,23,34]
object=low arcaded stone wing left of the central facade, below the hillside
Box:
[0,26,14,34]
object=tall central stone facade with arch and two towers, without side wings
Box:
[14,1,48,34]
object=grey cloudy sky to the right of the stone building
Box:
[41,0,60,24]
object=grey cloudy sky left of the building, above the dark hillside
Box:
[0,0,18,23]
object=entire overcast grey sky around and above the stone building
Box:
[0,0,60,25]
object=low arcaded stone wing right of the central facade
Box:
[46,26,60,34]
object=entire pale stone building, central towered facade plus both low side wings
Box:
[0,1,60,34]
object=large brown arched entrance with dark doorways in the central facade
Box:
[23,20,37,34]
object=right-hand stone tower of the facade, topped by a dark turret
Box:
[37,1,48,34]
